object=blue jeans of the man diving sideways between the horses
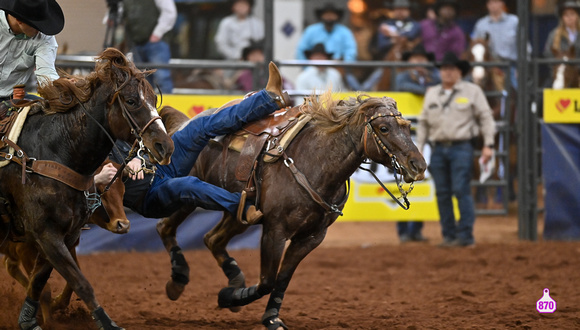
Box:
[141,90,279,218]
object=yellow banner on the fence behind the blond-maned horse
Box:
[163,92,439,221]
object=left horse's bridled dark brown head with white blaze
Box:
[95,48,173,165]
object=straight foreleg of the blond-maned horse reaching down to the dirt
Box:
[262,228,326,330]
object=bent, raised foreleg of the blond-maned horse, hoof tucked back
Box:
[218,222,286,308]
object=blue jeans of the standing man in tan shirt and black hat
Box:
[429,142,475,243]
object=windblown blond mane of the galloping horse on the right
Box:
[302,91,409,133]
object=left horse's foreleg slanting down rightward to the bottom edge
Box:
[37,231,123,330]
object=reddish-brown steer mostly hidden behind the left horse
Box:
[0,160,130,323]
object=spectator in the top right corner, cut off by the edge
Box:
[544,0,580,58]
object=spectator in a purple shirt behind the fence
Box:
[421,0,465,61]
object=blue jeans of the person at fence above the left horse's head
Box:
[131,40,173,94]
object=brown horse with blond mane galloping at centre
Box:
[157,93,426,329]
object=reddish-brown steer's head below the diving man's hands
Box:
[89,160,131,234]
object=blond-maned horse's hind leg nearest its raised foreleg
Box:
[203,212,248,312]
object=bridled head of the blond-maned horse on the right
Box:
[358,95,427,182]
